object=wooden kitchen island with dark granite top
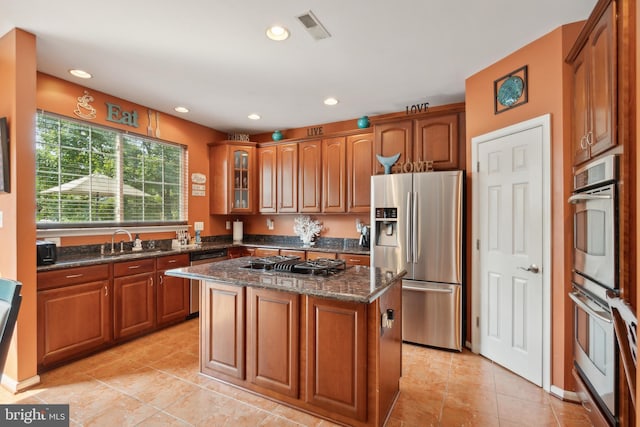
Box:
[166,257,404,426]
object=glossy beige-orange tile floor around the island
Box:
[0,319,590,427]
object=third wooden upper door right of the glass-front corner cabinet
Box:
[298,140,322,212]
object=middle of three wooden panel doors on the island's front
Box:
[247,288,300,398]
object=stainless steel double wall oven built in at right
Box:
[569,155,618,425]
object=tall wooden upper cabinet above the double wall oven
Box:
[567,1,617,165]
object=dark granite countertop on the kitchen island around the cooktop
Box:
[166,257,406,303]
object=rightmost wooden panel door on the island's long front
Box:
[305,296,367,420]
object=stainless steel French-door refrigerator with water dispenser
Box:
[371,171,463,351]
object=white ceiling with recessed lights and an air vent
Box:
[0,0,596,134]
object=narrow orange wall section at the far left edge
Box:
[0,29,37,390]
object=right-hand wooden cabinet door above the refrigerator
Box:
[413,114,460,170]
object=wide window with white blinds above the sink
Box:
[36,113,187,228]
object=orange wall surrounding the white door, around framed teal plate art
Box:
[466,22,583,390]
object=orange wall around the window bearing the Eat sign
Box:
[36,73,227,246]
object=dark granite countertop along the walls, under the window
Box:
[37,239,369,272]
